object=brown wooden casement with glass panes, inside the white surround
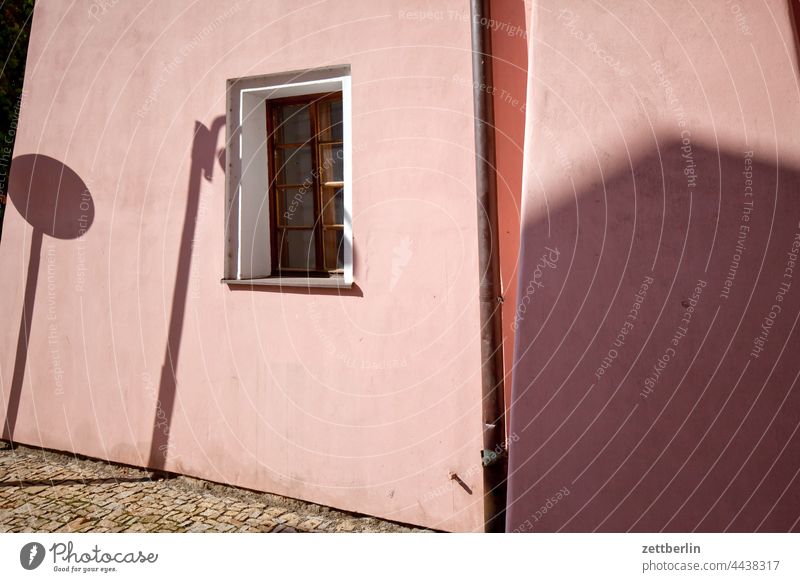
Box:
[266,92,345,277]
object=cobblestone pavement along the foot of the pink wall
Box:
[0,441,422,533]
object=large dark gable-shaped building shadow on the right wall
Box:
[507,137,800,532]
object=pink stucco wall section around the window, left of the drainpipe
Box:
[0,0,483,531]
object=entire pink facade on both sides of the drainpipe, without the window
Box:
[6,0,800,532]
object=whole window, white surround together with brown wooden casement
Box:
[222,65,354,289]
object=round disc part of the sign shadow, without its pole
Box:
[8,154,94,239]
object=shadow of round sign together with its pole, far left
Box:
[3,154,95,441]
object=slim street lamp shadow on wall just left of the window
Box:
[147,115,225,469]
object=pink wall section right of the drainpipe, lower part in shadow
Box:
[508,0,800,531]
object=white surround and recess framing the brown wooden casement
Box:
[222,67,353,288]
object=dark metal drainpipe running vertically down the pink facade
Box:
[470,0,508,532]
